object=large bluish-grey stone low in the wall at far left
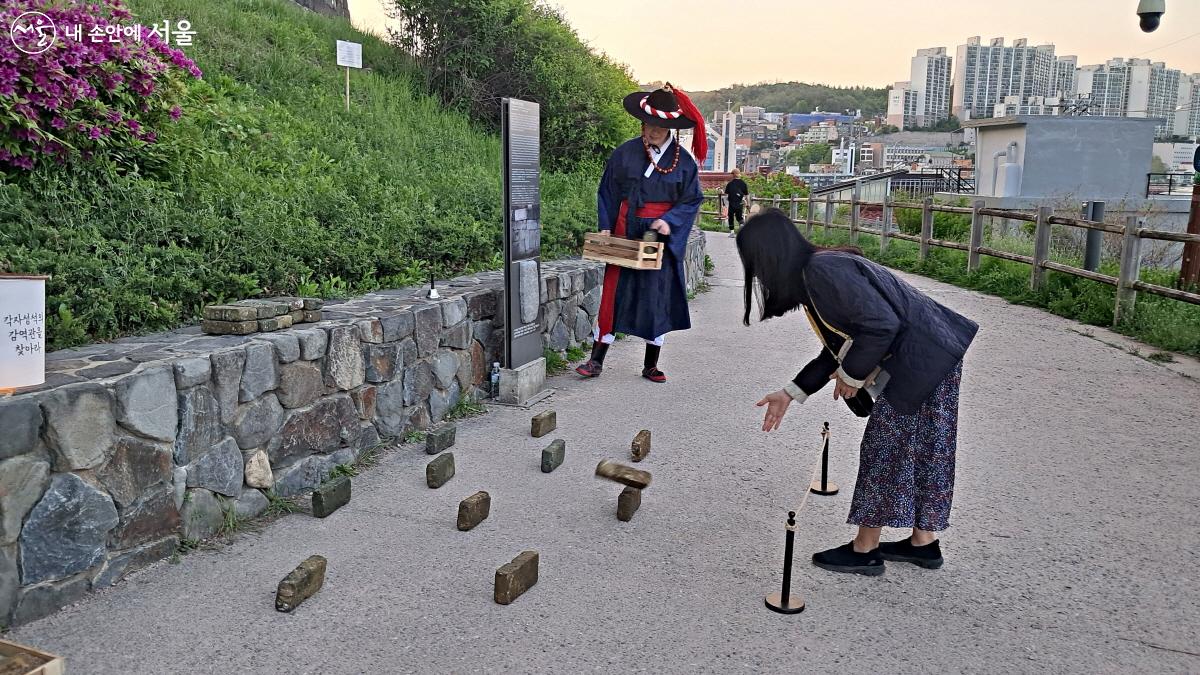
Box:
[20,473,120,586]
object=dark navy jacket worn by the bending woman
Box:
[793,251,979,414]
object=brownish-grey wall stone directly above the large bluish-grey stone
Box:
[42,384,116,471]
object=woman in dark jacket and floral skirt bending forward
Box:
[737,209,978,575]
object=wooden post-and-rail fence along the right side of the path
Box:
[701,190,1200,325]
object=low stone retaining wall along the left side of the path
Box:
[0,235,703,626]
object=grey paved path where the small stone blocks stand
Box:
[10,229,1200,674]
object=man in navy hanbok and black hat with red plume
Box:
[576,83,708,382]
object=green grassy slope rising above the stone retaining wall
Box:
[0,0,595,348]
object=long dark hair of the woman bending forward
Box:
[737,209,863,325]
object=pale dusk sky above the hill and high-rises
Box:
[550,0,1200,91]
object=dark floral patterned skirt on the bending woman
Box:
[848,362,962,531]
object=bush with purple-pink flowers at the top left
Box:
[0,0,202,174]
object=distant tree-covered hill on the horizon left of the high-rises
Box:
[695,82,888,118]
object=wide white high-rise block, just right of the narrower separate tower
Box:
[952,37,1057,120]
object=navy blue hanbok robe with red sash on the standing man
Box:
[596,137,703,340]
